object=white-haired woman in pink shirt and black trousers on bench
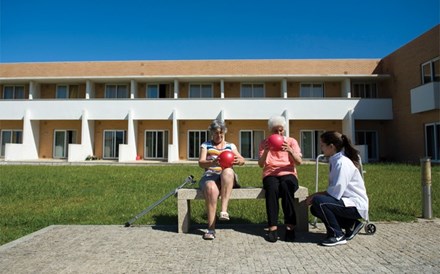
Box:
[258,116,302,242]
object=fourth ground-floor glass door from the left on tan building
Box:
[144,130,168,159]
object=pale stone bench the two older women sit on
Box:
[177,186,309,233]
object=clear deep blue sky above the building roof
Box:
[0,0,440,63]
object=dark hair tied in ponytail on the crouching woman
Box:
[321,131,361,168]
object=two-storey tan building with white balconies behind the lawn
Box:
[0,26,440,162]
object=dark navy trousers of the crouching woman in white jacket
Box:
[310,195,362,237]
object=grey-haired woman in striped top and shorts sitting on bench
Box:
[199,120,244,240]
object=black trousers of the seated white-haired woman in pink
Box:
[263,175,298,226]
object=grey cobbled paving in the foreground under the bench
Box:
[0,219,440,273]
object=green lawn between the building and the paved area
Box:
[0,164,440,244]
